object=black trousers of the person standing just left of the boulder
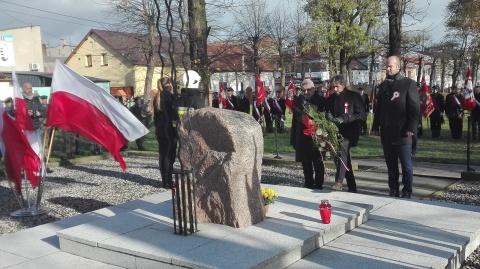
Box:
[157,136,177,188]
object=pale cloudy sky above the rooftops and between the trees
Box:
[0,0,450,47]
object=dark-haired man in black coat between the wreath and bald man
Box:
[327,75,365,192]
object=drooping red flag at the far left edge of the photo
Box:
[0,103,40,193]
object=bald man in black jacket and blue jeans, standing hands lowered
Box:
[372,56,420,198]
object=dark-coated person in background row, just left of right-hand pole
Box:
[445,86,464,140]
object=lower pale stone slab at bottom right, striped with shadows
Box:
[288,198,480,269]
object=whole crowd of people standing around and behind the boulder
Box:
[4,63,480,198]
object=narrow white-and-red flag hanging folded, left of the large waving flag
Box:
[12,71,42,188]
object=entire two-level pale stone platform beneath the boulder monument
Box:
[51,184,480,268]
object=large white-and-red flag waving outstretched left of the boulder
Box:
[46,60,148,171]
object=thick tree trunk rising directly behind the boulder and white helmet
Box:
[188,0,210,106]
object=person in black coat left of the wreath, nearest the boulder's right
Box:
[290,79,325,190]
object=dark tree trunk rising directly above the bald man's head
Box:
[388,0,405,56]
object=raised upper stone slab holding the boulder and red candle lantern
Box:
[57,185,376,268]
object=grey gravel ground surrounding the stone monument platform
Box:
[0,157,480,269]
